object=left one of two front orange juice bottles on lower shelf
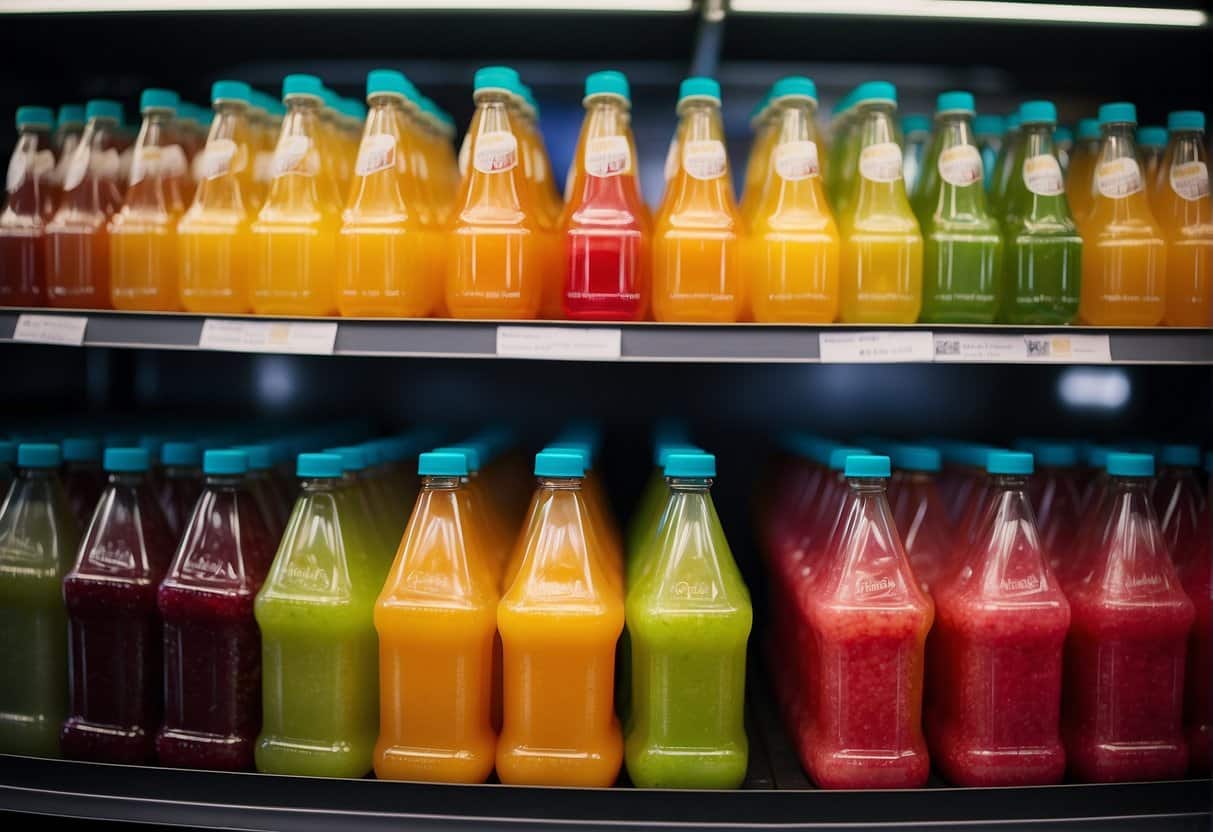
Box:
[375,450,499,782]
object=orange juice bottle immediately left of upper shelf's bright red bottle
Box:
[445,67,545,318]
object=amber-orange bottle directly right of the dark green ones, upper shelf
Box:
[1078,102,1167,326]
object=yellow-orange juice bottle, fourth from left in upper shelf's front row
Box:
[177,81,256,314]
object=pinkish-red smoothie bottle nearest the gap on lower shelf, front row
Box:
[802,455,934,788]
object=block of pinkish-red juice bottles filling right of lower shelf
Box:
[758,435,1213,788]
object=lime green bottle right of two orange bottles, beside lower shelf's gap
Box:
[625,452,753,788]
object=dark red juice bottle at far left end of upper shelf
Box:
[0,107,56,306]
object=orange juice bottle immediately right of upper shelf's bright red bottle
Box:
[653,78,745,323]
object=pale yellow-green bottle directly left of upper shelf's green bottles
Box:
[838,81,922,324]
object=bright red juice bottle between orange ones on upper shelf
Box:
[557,72,651,320]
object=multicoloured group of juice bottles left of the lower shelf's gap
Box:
[0,428,752,788]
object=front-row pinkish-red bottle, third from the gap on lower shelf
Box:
[1063,456,1194,782]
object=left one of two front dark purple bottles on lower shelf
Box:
[59,448,176,763]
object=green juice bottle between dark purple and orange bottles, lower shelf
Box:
[254,454,385,777]
